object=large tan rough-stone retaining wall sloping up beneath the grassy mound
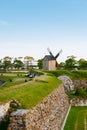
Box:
[8,85,69,130]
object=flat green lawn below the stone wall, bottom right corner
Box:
[64,106,87,130]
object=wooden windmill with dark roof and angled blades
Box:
[43,48,62,70]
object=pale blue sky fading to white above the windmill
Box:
[0,0,87,62]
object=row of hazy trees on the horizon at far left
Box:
[0,56,34,71]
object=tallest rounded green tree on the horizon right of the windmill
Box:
[65,55,77,70]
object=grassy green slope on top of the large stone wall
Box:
[0,73,61,108]
